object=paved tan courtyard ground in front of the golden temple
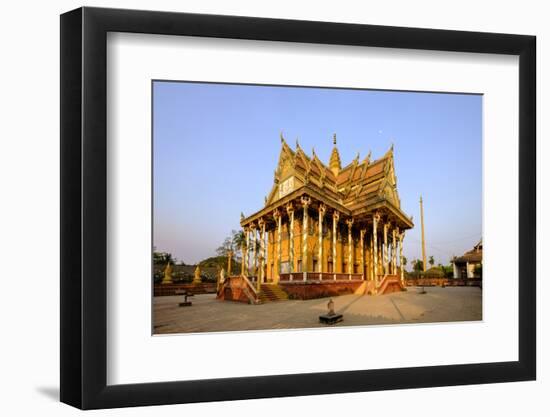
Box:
[153,287,482,334]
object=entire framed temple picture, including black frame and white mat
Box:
[59,7,537,409]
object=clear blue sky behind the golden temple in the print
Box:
[153,81,482,264]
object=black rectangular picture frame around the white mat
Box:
[60,7,536,409]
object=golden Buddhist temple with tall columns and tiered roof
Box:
[219,135,413,300]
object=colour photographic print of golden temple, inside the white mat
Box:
[152,80,483,334]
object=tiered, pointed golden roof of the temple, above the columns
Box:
[241,135,413,228]
